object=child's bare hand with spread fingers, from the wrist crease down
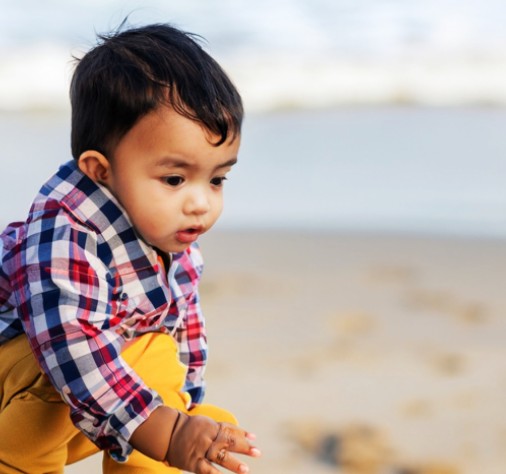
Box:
[166,413,260,474]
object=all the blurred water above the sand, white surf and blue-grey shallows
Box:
[0,0,506,237]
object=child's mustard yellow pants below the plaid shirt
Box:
[0,333,237,474]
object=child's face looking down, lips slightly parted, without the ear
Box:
[105,107,240,252]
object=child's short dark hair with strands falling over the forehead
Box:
[70,24,243,160]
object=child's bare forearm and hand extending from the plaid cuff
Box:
[130,406,260,474]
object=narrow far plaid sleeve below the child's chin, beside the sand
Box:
[169,244,207,403]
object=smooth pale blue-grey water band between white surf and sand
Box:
[0,107,506,238]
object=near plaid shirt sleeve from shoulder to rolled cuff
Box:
[19,218,163,461]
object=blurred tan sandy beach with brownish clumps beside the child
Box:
[65,231,506,474]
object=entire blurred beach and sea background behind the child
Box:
[0,0,506,474]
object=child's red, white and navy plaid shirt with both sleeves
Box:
[0,162,207,460]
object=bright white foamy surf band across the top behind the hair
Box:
[0,0,506,111]
